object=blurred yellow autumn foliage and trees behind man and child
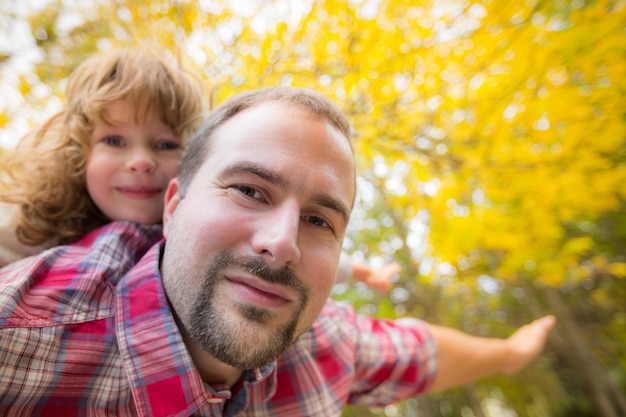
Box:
[0,0,626,417]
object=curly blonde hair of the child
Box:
[0,49,205,246]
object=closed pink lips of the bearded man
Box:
[226,276,295,308]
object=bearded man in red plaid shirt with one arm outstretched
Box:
[0,88,554,416]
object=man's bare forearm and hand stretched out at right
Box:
[431,316,556,391]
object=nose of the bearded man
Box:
[252,201,300,268]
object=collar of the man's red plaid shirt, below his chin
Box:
[115,241,276,415]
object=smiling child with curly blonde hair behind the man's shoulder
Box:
[0,49,204,266]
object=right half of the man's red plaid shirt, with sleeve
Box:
[256,300,437,416]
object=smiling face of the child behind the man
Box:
[87,100,183,224]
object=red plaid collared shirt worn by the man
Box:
[0,222,437,417]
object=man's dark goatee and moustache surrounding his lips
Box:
[186,253,309,369]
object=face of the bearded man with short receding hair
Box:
[162,102,355,369]
